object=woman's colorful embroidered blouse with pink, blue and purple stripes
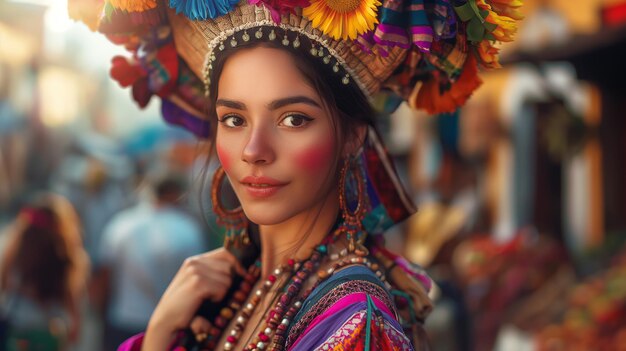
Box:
[118,265,414,351]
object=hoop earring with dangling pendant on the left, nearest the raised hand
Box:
[211,166,250,249]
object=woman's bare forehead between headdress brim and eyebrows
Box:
[218,47,319,101]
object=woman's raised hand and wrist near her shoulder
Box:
[142,248,246,351]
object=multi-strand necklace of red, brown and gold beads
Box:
[194,238,384,351]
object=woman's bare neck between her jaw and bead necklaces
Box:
[259,190,339,277]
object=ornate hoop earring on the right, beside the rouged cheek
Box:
[336,157,368,256]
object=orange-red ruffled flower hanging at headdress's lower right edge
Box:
[409,55,482,115]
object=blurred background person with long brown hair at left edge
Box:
[0,194,89,351]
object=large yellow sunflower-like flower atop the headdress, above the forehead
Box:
[302,0,381,40]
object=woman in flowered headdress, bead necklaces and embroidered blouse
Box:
[70,0,520,351]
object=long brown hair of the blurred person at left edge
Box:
[0,195,89,303]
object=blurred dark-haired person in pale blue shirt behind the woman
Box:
[94,173,206,351]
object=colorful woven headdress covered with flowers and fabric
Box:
[69,0,522,137]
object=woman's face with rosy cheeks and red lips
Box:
[216,47,339,225]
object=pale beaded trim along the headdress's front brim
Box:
[203,20,371,100]
